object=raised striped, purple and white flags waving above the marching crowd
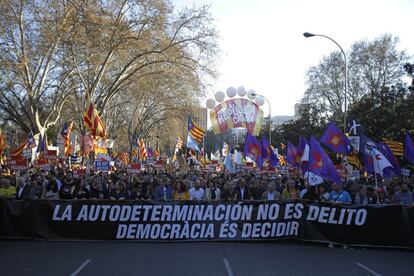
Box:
[0,88,414,188]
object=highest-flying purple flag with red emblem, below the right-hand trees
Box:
[320,122,351,155]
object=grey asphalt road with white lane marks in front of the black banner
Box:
[0,241,414,276]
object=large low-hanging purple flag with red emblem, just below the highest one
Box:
[309,136,341,184]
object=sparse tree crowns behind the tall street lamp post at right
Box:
[303,34,408,121]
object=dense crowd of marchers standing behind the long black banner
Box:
[0,165,414,205]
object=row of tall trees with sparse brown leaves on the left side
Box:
[0,0,219,153]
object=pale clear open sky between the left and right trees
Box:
[172,0,414,116]
